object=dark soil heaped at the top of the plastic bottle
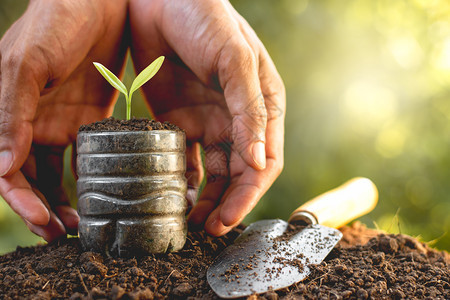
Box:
[78,117,182,132]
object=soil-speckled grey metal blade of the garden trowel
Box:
[207,219,342,298]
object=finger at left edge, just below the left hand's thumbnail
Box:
[0,172,50,226]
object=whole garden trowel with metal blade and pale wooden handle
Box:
[207,177,378,298]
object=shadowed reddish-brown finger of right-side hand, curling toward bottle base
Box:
[188,144,229,226]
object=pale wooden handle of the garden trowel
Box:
[289,177,378,228]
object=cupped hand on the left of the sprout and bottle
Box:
[0,0,128,241]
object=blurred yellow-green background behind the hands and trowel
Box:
[0,0,450,253]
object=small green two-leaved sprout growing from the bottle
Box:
[94,56,164,120]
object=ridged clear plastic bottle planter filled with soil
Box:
[77,130,187,256]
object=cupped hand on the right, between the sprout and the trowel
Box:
[130,0,285,236]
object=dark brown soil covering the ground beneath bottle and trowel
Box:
[0,223,450,299]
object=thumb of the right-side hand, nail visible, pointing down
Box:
[218,39,267,170]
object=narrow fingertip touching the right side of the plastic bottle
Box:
[186,142,203,206]
